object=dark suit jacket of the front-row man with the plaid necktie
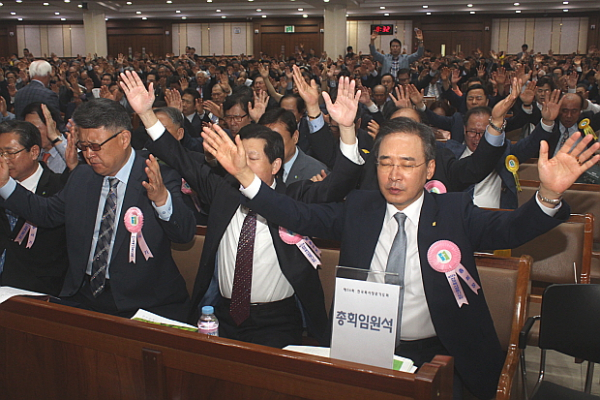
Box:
[4,152,195,320]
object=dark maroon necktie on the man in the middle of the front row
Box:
[229,211,256,325]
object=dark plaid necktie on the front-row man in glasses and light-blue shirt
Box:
[90,178,119,297]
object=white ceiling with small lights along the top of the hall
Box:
[0,0,600,22]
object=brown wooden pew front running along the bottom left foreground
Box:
[0,297,453,400]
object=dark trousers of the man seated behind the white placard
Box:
[394,336,472,400]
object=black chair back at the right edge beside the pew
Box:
[539,284,600,363]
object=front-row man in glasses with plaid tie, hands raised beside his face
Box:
[0,99,195,320]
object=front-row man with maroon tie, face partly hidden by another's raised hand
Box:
[121,69,358,347]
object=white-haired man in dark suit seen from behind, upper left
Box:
[15,60,60,119]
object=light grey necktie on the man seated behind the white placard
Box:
[385,212,406,346]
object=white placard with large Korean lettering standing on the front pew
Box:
[331,278,400,368]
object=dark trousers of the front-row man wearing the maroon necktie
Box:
[215,296,303,348]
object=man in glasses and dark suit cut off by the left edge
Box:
[0,121,69,296]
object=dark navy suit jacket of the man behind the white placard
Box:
[245,184,570,398]
